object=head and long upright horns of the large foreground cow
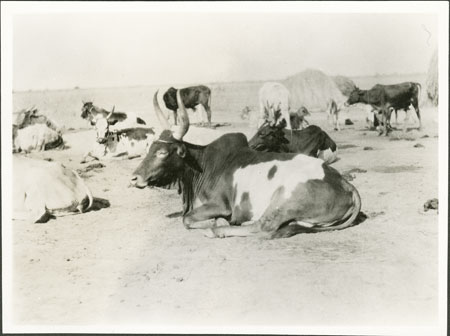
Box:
[131,90,196,188]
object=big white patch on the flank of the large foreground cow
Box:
[233,154,325,220]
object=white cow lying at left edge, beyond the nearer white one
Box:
[13,123,64,153]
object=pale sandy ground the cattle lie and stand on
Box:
[6,108,439,326]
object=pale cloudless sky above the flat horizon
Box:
[13,12,438,90]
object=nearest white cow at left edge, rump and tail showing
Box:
[12,155,93,223]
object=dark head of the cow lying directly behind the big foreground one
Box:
[248,119,289,153]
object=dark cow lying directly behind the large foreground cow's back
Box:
[248,120,337,164]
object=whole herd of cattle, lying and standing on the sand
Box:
[13,82,421,238]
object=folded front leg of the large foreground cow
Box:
[183,204,231,229]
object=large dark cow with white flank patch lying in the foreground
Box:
[131,93,361,239]
